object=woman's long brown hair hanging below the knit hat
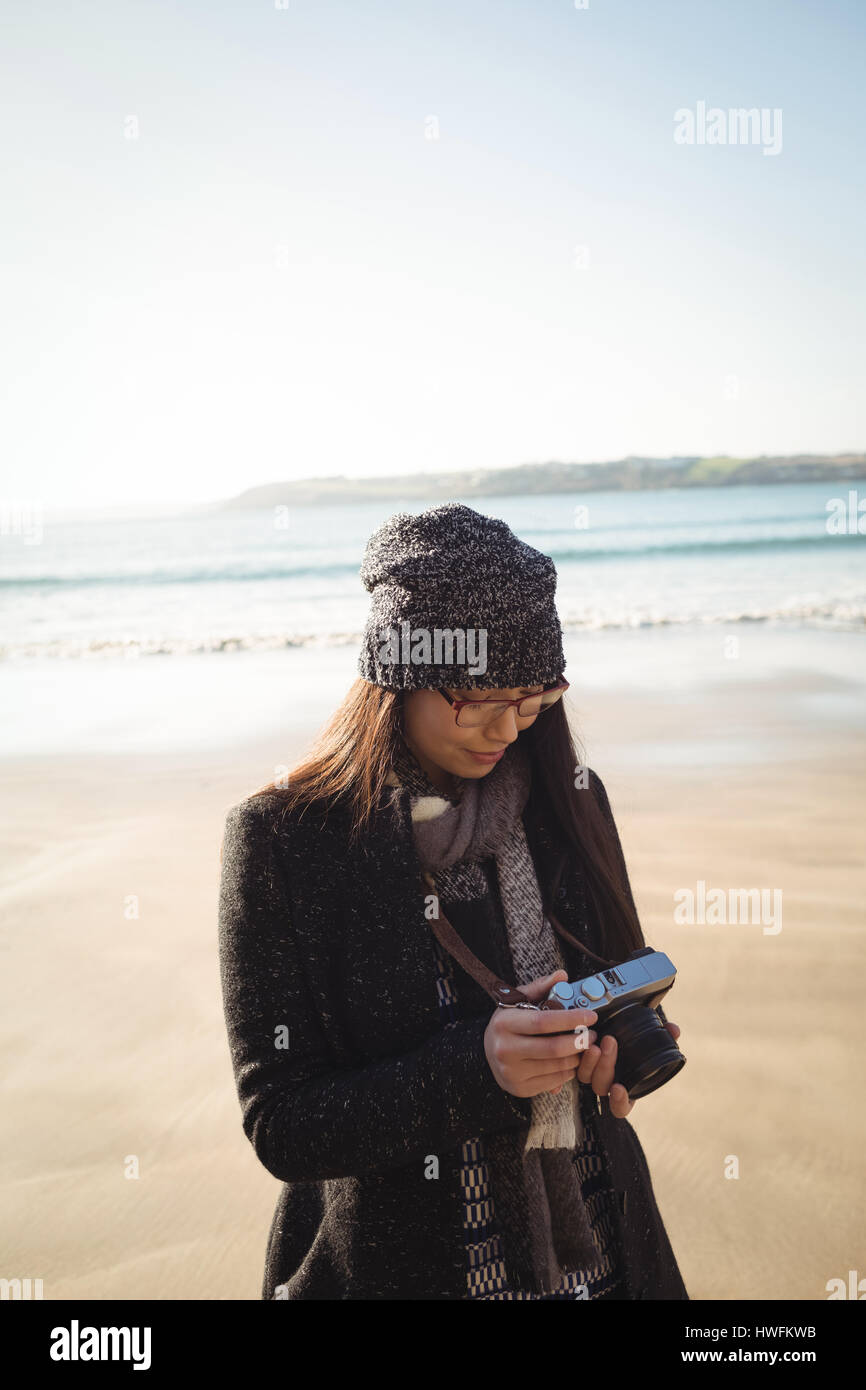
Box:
[241,677,644,960]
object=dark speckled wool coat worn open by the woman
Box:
[218,774,688,1300]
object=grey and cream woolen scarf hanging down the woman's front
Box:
[389,738,602,1293]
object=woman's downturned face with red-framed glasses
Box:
[403,685,544,792]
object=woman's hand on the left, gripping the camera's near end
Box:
[484,970,598,1098]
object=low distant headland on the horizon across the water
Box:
[221,453,866,512]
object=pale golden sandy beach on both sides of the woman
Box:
[0,630,866,1300]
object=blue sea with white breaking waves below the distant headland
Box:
[0,482,866,662]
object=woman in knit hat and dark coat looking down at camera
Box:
[220,503,688,1300]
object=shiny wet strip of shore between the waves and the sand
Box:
[0,628,866,766]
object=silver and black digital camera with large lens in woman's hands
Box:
[539,947,685,1101]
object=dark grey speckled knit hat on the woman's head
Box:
[357,502,566,689]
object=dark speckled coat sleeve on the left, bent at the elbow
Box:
[218,799,531,1182]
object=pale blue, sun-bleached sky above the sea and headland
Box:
[0,0,866,507]
